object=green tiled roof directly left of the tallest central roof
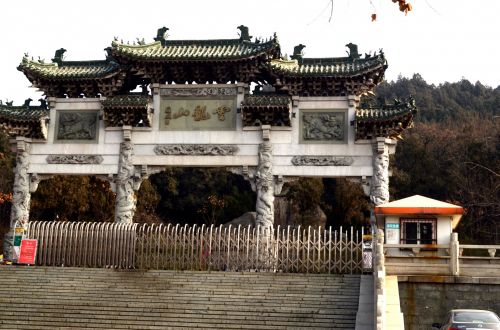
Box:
[18,57,120,79]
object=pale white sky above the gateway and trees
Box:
[0,0,500,105]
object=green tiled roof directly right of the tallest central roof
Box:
[270,53,387,77]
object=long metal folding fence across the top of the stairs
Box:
[27,221,371,274]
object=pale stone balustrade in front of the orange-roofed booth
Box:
[384,233,500,277]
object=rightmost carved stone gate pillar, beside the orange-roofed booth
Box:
[370,138,389,206]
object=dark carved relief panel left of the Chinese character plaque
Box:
[54,111,99,143]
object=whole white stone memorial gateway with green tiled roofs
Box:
[0,27,416,262]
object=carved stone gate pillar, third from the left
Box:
[255,125,274,229]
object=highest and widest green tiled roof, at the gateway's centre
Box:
[112,38,279,61]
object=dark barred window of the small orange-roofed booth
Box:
[401,219,437,244]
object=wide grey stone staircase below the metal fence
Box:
[0,266,360,329]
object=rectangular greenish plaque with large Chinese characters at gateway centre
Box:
[160,96,236,131]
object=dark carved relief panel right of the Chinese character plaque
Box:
[300,110,347,143]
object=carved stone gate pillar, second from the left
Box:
[114,127,137,224]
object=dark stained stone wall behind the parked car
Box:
[399,276,500,330]
